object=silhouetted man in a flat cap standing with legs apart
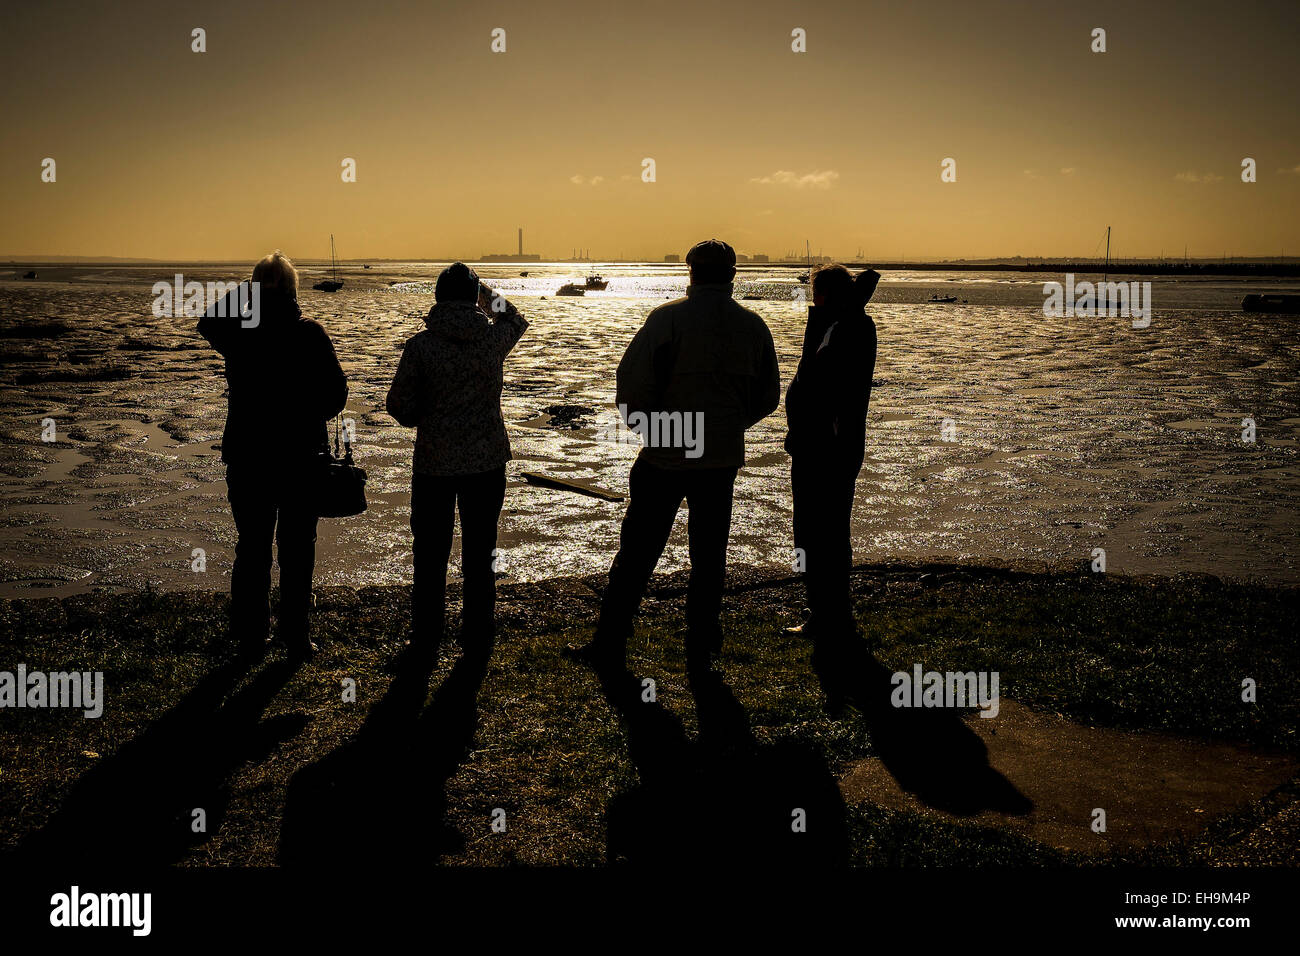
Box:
[568,239,781,669]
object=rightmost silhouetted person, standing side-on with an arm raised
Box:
[785,265,880,649]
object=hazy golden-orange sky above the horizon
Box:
[0,0,1300,260]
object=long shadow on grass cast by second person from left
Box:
[280,646,491,871]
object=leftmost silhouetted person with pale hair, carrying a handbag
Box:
[199,251,347,657]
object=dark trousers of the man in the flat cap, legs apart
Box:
[597,459,737,656]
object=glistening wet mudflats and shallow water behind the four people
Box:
[0,263,1300,596]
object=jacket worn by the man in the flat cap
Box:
[615,282,781,468]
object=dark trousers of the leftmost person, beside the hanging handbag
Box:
[226,464,316,643]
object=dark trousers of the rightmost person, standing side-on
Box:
[790,455,862,637]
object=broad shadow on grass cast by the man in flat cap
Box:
[601,660,849,868]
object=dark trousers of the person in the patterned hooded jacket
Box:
[411,466,506,643]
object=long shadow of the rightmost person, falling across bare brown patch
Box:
[813,646,1034,816]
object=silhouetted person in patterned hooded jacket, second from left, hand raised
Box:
[387,263,528,653]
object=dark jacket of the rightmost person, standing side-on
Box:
[785,306,876,470]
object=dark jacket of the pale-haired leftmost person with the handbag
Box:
[199,287,347,468]
